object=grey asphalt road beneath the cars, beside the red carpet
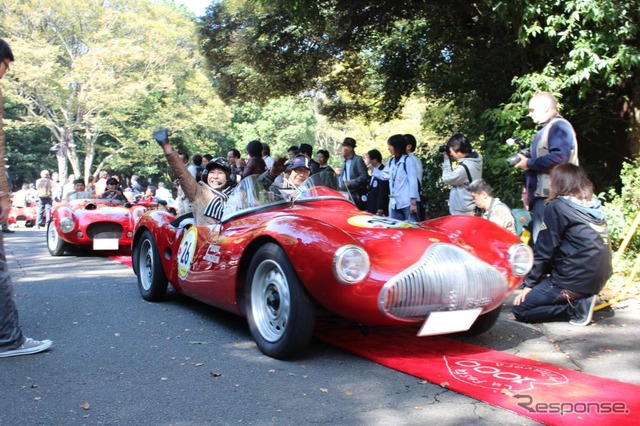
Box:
[0,229,637,425]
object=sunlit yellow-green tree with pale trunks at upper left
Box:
[0,0,228,186]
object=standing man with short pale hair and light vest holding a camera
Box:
[514,92,578,242]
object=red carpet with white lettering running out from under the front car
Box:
[316,323,640,425]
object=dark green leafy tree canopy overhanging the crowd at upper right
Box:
[200,0,640,198]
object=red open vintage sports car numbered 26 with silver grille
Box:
[132,173,533,358]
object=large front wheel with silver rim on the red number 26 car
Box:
[245,243,316,359]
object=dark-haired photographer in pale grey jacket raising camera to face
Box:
[440,133,482,215]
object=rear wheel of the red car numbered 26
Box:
[134,230,169,302]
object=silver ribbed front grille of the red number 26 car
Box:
[378,243,507,321]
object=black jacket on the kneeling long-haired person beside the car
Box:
[524,197,612,294]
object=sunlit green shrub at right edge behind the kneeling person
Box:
[600,161,640,254]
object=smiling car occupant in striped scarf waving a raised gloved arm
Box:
[153,129,235,225]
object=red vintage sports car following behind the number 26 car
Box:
[47,198,169,256]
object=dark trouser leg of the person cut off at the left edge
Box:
[0,233,25,352]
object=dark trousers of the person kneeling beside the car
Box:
[513,279,589,322]
